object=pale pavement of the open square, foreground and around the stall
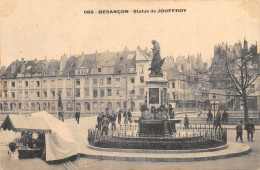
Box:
[0,117,260,170]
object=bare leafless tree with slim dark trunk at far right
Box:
[212,41,259,122]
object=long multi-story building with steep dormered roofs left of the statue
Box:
[0,47,152,113]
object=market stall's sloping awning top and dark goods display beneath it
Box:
[1,115,51,159]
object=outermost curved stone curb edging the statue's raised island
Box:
[80,145,251,162]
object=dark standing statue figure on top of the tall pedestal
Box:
[149,40,164,76]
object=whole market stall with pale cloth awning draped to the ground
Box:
[1,111,79,161]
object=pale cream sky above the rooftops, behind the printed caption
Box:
[0,0,260,66]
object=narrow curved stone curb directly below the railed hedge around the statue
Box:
[87,144,228,154]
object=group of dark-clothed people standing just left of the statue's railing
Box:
[96,108,132,135]
